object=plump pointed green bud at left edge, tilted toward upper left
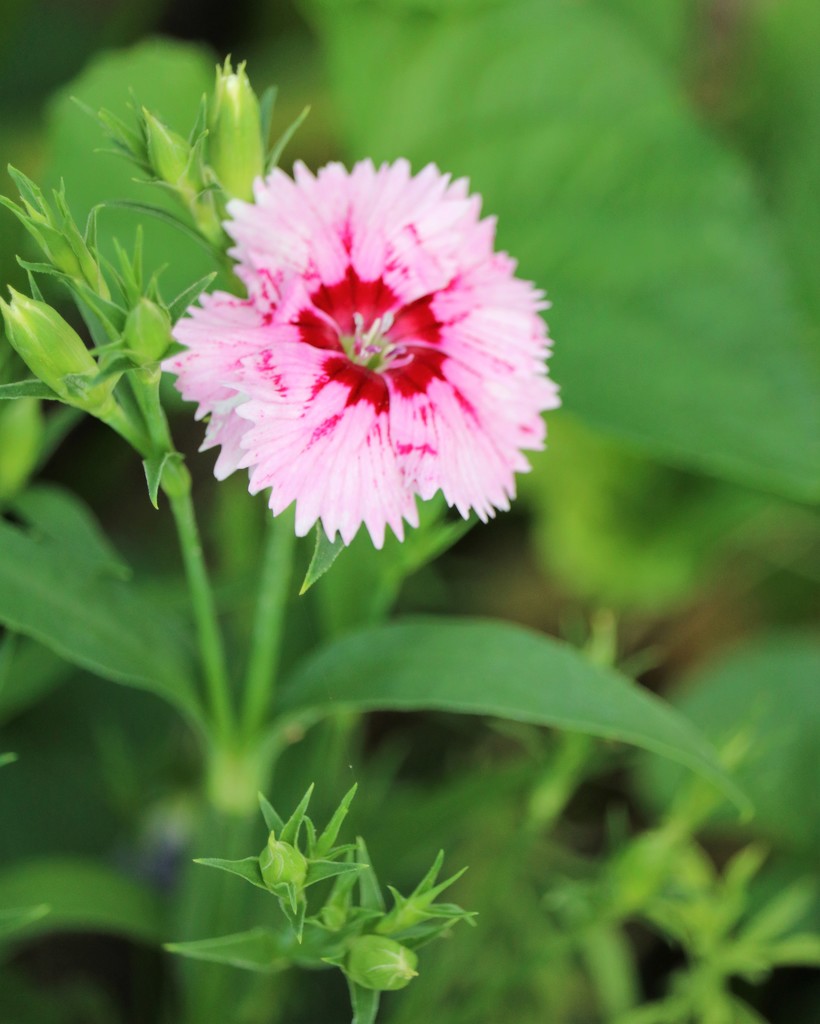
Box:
[0,288,116,418]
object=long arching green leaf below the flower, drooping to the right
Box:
[278,617,746,805]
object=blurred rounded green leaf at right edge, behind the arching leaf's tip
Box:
[638,633,820,857]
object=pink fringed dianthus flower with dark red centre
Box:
[164,160,559,548]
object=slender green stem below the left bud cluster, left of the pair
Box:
[166,488,233,740]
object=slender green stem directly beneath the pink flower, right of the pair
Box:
[242,516,296,736]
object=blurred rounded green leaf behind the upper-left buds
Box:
[45,39,215,296]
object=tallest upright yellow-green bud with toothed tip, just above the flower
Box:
[208,58,265,200]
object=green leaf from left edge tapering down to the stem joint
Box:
[0,499,200,721]
